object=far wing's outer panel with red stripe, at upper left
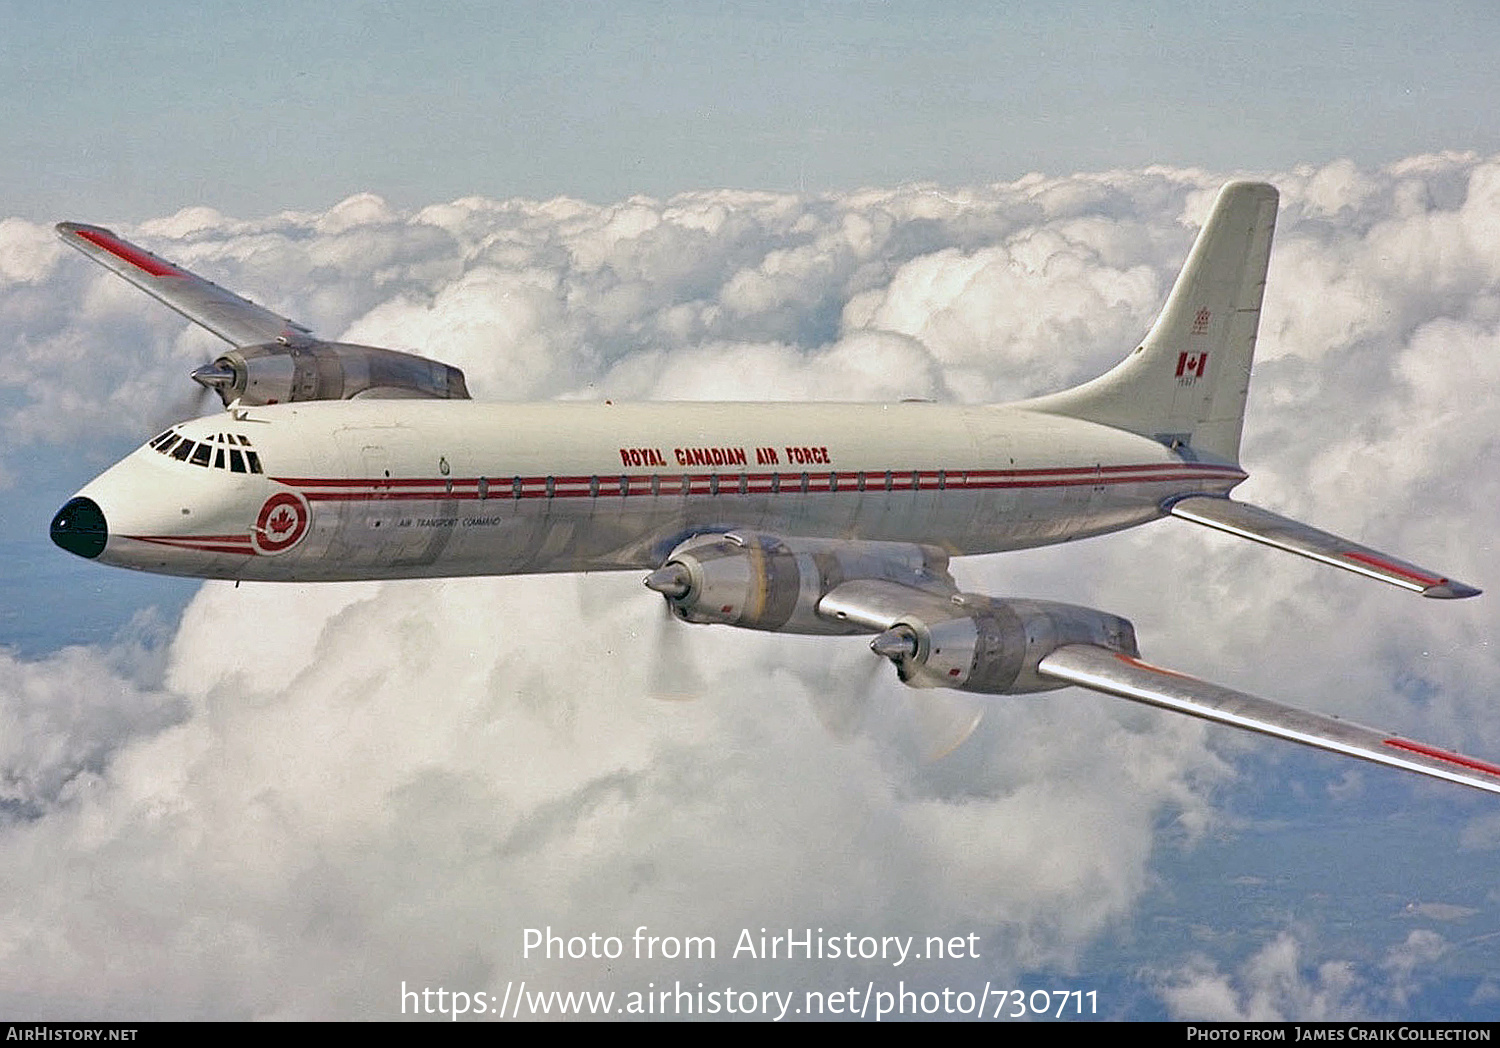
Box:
[57,222,312,348]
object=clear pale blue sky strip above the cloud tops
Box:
[11,0,1500,220]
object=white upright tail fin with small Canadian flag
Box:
[1017,181,1278,463]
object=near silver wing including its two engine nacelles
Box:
[647,531,1500,793]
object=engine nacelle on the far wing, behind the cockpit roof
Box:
[192,339,468,406]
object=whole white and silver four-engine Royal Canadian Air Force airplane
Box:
[51,183,1500,793]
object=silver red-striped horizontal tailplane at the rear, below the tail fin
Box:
[1167,495,1481,598]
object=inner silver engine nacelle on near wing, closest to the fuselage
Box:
[647,531,953,636]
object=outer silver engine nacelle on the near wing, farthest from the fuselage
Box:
[870,594,1140,694]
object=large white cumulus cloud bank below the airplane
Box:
[0,579,1218,1017]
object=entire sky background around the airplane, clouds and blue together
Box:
[0,0,1500,1018]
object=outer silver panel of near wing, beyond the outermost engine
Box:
[1037,645,1500,793]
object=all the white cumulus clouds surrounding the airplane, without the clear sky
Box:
[0,156,1500,1018]
